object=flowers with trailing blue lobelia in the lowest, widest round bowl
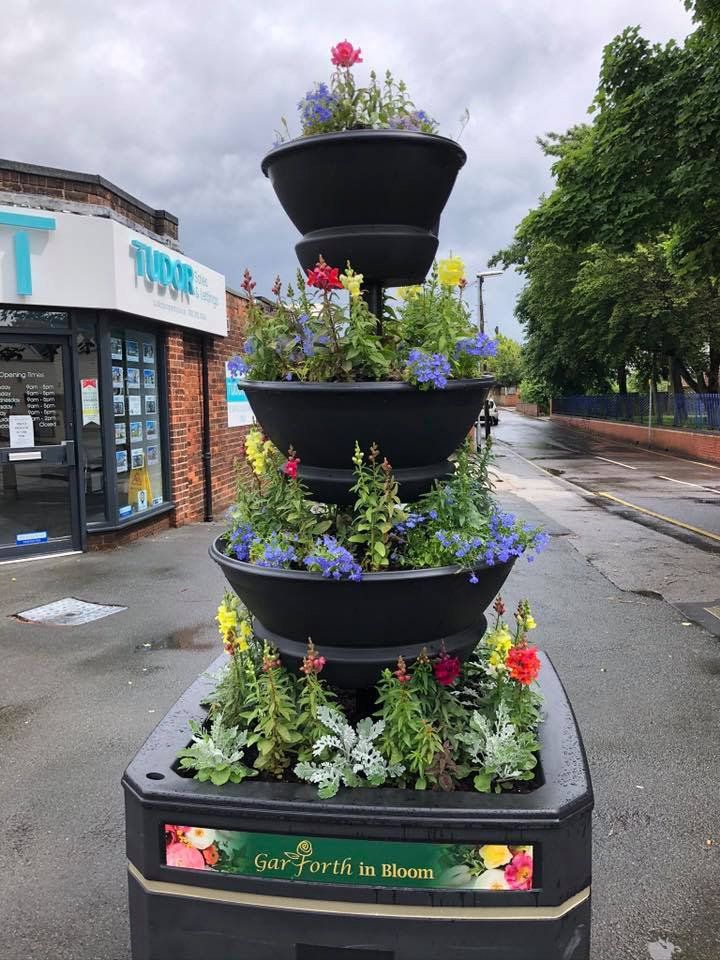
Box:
[225,430,548,580]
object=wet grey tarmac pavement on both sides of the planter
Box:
[0,464,720,960]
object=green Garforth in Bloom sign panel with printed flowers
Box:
[165,824,533,891]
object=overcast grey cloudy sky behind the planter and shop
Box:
[0,0,692,339]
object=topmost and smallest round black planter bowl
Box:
[262,130,467,286]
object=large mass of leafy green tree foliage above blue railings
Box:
[490,0,720,392]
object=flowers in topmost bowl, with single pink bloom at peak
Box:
[276,40,437,146]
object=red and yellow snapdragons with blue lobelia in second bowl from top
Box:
[229,256,497,390]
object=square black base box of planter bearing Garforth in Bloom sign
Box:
[123,655,593,960]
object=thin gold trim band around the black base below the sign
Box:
[128,863,590,921]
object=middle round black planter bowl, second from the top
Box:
[243,374,495,504]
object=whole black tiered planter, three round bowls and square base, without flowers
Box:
[123,124,593,960]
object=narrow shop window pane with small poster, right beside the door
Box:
[76,322,106,523]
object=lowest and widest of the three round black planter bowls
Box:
[210,537,515,689]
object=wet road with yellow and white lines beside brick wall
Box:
[493,410,720,635]
